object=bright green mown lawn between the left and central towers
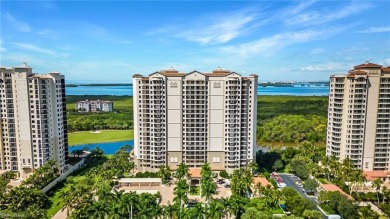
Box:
[68,130,133,145]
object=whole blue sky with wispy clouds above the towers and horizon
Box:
[0,1,390,82]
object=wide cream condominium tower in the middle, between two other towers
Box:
[133,68,257,172]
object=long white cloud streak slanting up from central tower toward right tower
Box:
[220,28,343,57]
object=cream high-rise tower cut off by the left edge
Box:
[0,64,68,178]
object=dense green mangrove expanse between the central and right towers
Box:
[257,96,328,146]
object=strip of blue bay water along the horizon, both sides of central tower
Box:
[65,84,329,96]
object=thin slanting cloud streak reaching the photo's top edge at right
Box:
[285,2,372,25]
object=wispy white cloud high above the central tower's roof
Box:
[149,10,262,45]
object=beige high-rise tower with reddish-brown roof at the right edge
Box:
[326,62,390,171]
